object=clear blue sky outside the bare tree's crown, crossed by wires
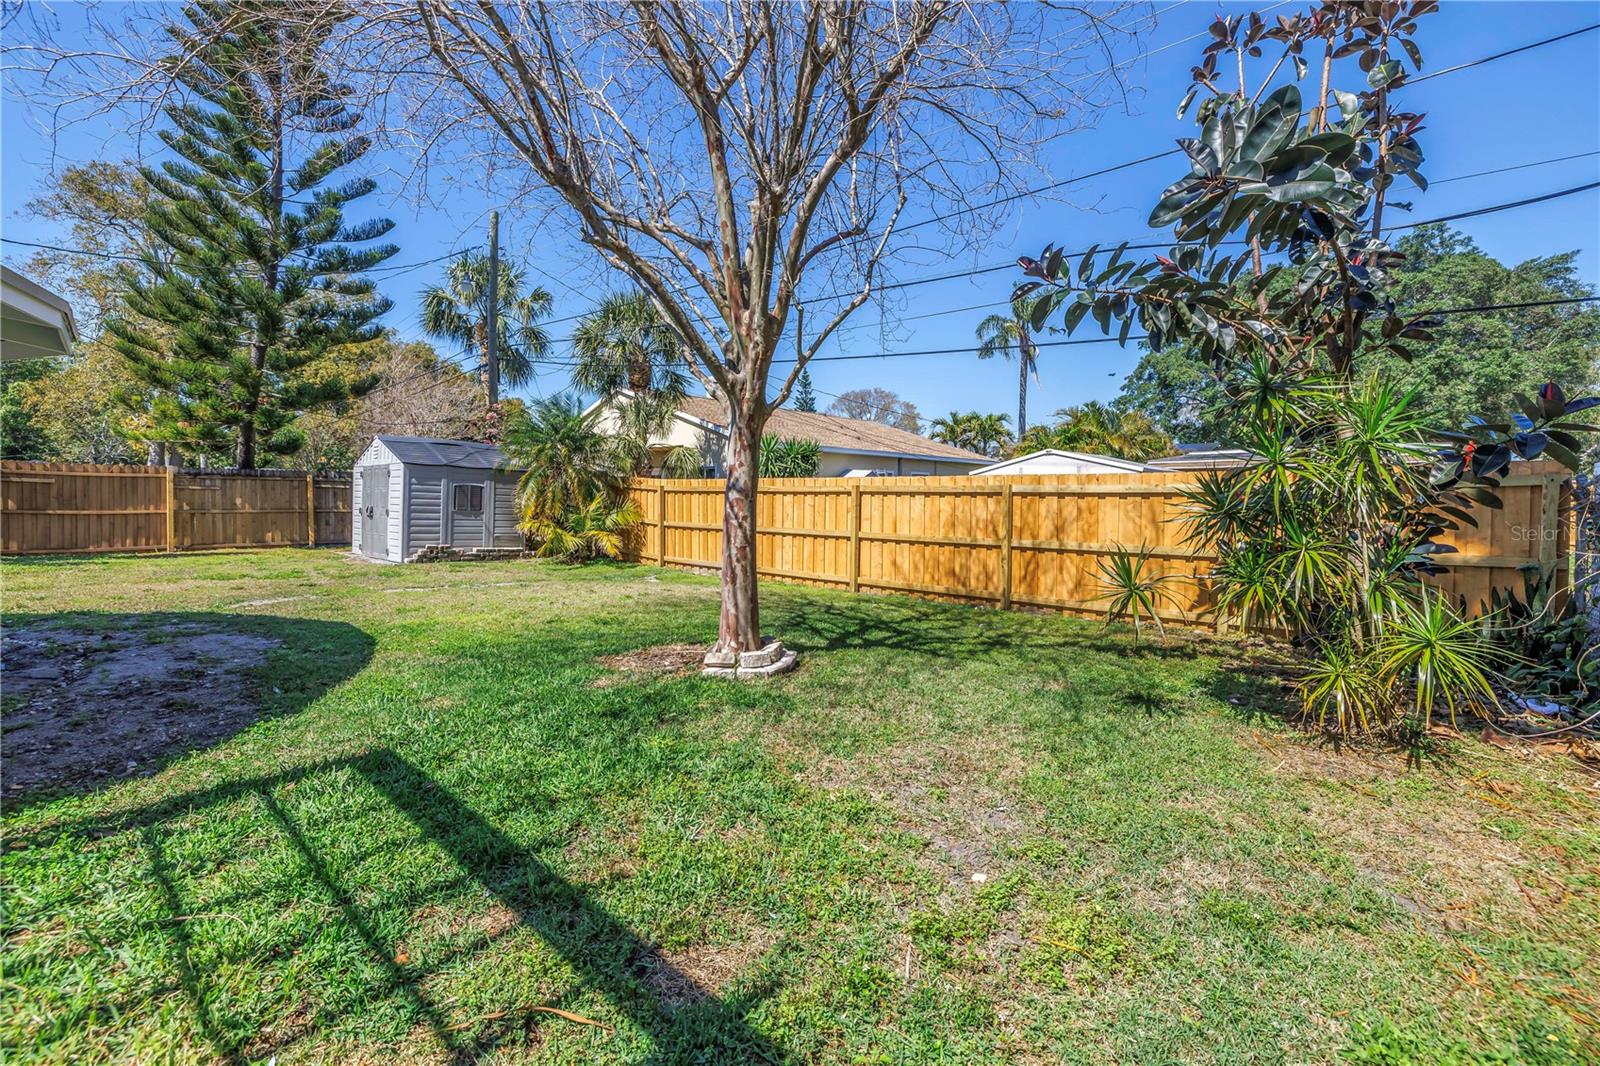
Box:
[0,0,1600,421]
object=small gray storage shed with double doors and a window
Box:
[350,434,522,562]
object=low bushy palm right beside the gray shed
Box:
[501,395,630,528]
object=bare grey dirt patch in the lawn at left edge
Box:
[3,624,282,797]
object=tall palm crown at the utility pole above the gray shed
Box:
[422,251,552,400]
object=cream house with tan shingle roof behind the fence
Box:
[589,394,994,477]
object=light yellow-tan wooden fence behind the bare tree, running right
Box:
[627,463,1571,623]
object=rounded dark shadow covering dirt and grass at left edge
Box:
[3,611,374,807]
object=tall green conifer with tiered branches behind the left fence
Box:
[107,3,395,469]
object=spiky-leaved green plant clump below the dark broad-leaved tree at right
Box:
[1184,375,1509,733]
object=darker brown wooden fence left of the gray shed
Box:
[0,459,350,555]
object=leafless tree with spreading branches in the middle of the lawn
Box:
[6,0,1149,659]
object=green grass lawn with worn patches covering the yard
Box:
[0,549,1600,1063]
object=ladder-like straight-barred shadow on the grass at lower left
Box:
[6,747,787,1063]
